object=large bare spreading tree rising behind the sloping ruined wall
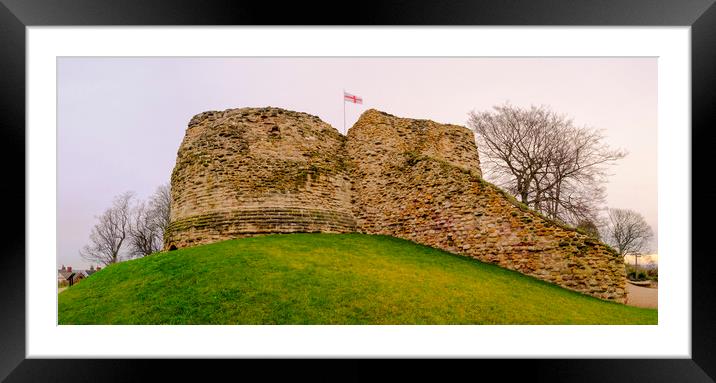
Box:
[468,104,626,224]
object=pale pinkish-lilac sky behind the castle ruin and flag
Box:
[57,58,658,269]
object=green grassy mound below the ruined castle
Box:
[58,234,657,324]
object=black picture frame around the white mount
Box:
[0,0,716,382]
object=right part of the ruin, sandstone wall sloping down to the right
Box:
[347,110,625,302]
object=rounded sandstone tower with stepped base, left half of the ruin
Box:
[165,108,355,248]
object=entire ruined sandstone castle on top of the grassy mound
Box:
[165,108,626,302]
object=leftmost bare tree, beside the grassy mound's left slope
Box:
[80,192,134,266]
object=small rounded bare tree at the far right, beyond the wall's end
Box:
[604,209,653,269]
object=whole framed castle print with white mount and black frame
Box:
[0,0,716,382]
